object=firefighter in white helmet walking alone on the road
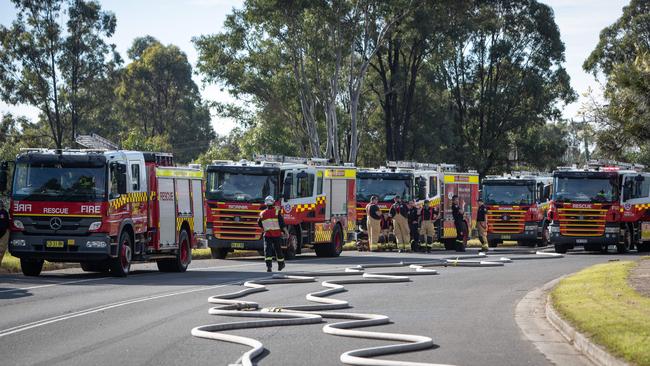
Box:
[257,196,286,272]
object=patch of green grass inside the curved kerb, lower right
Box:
[551,261,650,365]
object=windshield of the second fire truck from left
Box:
[205,172,278,202]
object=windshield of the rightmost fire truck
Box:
[555,177,618,203]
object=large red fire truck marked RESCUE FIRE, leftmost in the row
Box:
[0,136,204,277]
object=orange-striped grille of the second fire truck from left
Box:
[210,208,262,240]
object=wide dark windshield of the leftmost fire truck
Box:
[13,163,107,202]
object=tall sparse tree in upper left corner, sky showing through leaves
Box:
[0,0,120,148]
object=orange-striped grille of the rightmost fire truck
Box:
[558,208,607,236]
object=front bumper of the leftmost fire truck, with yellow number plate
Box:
[9,232,112,262]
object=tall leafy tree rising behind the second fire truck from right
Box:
[442,0,575,175]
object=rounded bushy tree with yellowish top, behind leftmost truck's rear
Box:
[116,36,215,162]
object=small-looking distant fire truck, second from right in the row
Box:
[482,172,553,248]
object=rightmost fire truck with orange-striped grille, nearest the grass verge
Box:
[544,162,643,253]
